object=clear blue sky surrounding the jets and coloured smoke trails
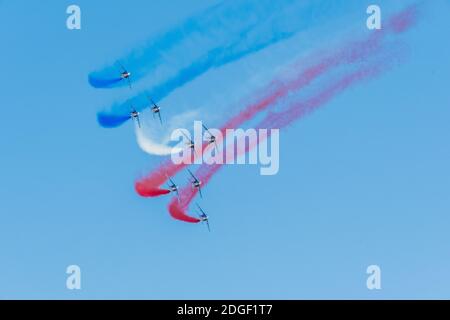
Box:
[0,0,450,299]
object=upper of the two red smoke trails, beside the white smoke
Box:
[135,6,417,197]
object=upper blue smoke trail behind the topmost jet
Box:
[89,0,295,88]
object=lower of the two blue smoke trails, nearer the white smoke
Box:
[100,0,353,125]
